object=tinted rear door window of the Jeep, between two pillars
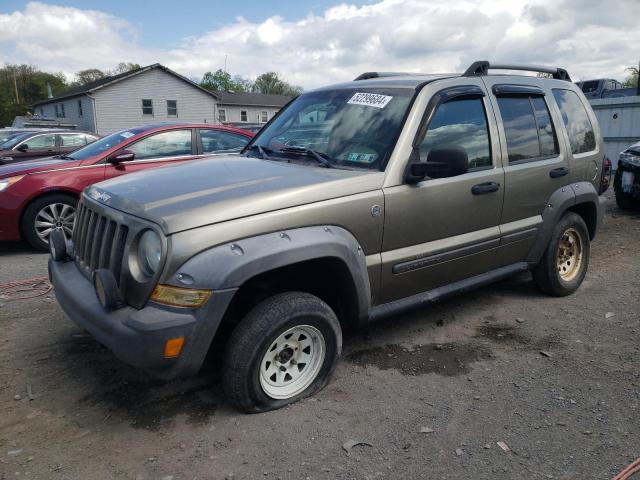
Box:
[498,97,558,163]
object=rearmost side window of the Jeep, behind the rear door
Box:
[553,89,596,154]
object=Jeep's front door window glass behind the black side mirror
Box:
[420,98,492,169]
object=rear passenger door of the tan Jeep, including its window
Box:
[484,77,582,261]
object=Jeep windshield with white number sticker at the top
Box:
[245,88,414,169]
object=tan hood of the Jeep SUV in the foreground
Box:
[86,156,384,234]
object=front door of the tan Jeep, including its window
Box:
[381,88,504,302]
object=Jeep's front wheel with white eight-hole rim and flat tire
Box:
[222,292,342,413]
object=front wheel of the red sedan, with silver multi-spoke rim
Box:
[21,193,78,252]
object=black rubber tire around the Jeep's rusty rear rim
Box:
[532,212,591,297]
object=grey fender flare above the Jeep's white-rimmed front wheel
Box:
[167,225,371,323]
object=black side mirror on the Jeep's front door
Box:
[405,146,469,183]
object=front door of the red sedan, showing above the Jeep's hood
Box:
[105,128,198,178]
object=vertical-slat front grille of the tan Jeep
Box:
[72,202,129,284]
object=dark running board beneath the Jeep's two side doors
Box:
[369,262,529,323]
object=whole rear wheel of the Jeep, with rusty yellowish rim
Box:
[533,212,591,297]
